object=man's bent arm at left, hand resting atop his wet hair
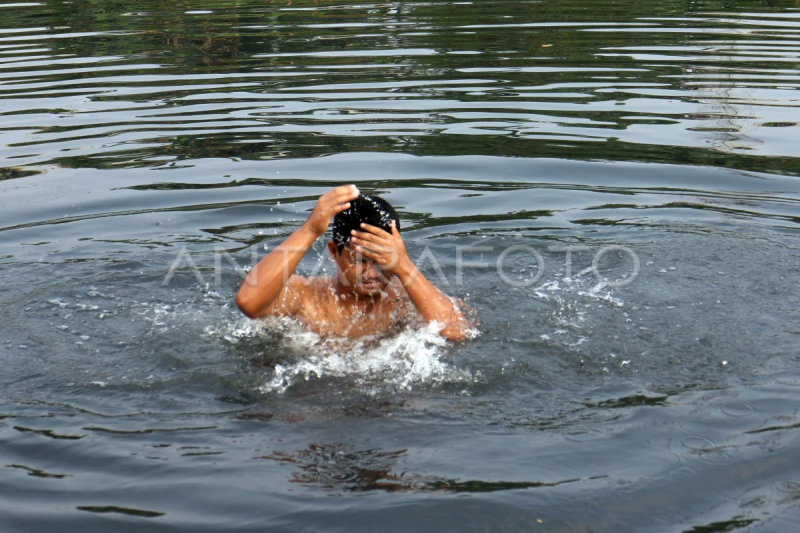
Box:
[231,185,359,318]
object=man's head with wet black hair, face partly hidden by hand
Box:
[328,195,400,296]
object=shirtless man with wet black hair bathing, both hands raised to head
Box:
[236,185,474,340]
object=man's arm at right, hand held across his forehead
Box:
[352,221,474,341]
